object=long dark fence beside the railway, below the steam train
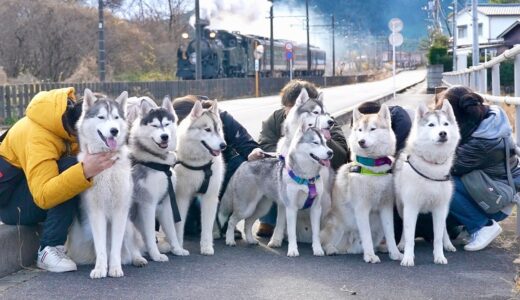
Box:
[0,75,371,123]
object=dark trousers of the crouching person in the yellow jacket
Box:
[0,156,79,249]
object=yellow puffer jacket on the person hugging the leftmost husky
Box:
[0,88,92,209]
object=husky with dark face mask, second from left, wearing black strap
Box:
[129,97,189,261]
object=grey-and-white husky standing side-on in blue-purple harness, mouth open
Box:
[219,123,332,256]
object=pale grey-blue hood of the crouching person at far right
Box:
[471,105,513,139]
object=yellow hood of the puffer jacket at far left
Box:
[25,87,75,141]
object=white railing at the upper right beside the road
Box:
[442,44,520,235]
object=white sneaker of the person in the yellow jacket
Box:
[36,246,78,273]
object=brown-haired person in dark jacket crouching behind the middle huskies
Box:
[256,80,349,237]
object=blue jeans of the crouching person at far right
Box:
[448,176,507,234]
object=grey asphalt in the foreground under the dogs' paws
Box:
[0,73,519,299]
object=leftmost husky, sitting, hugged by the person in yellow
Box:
[67,89,132,278]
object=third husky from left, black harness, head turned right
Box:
[174,101,226,255]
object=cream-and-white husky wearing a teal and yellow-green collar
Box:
[321,104,402,263]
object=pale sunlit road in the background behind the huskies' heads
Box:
[219,70,426,138]
